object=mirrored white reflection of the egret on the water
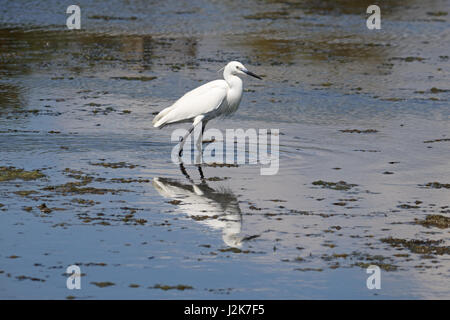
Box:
[153,163,242,248]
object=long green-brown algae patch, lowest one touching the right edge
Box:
[380,237,450,255]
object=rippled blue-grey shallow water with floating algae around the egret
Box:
[0,1,450,299]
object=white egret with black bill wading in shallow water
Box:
[153,61,262,157]
